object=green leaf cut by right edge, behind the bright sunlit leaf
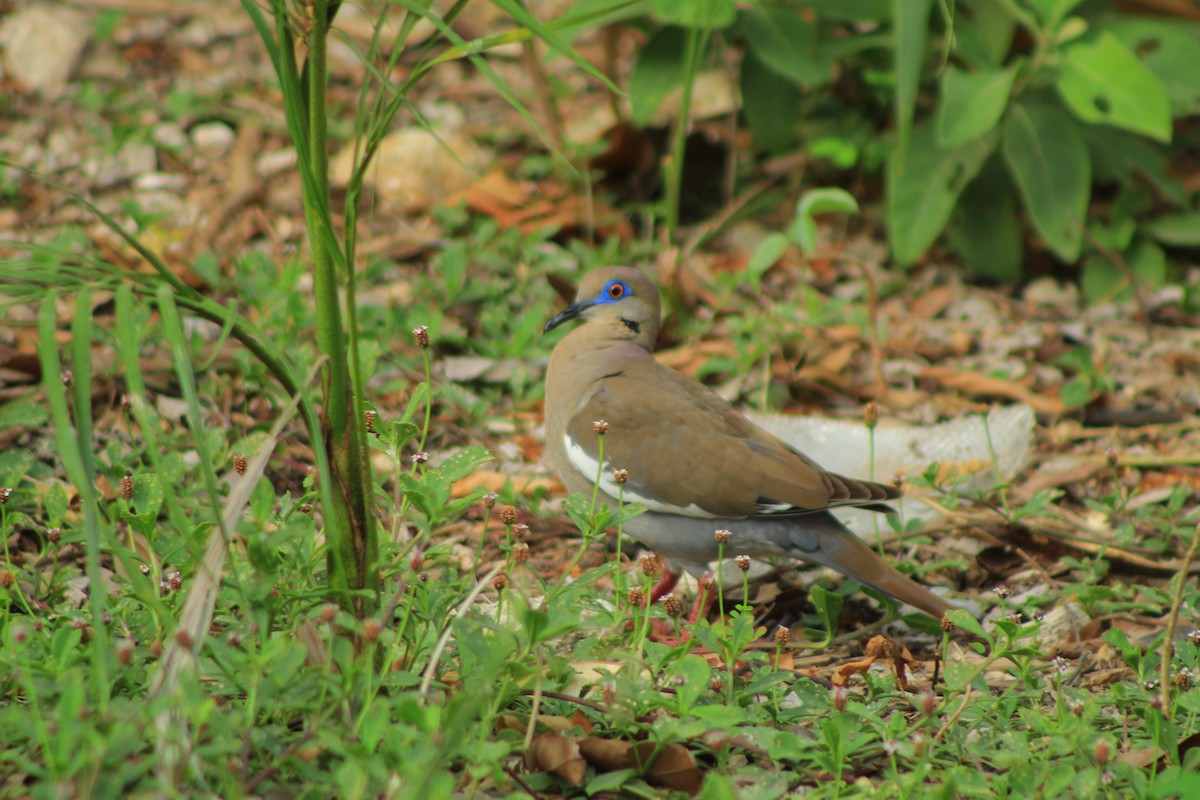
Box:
[1105,17,1200,118]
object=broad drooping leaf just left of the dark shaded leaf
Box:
[887,125,996,264]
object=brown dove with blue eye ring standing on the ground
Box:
[545,266,954,619]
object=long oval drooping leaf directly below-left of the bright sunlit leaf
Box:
[1003,102,1092,264]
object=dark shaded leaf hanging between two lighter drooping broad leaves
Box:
[950,157,1025,282]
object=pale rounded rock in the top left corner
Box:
[0,2,91,97]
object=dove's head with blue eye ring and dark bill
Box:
[544,266,661,350]
